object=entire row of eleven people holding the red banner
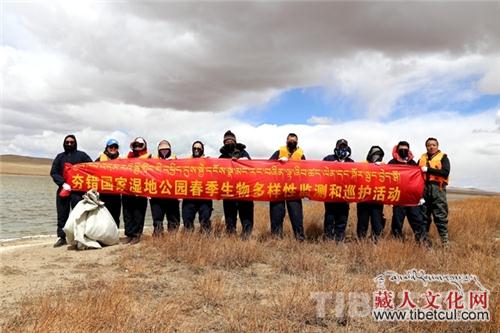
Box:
[50,130,450,247]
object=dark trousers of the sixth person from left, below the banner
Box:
[222,200,253,238]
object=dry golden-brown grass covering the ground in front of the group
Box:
[2,197,500,332]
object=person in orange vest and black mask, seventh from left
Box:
[269,133,306,241]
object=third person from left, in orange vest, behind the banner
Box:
[122,137,151,245]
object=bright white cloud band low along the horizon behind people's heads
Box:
[0,105,500,191]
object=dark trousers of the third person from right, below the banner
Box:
[356,202,385,240]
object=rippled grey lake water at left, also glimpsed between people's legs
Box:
[0,175,222,239]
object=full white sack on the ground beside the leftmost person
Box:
[64,190,119,249]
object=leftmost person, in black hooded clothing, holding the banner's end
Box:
[50,134,92,247]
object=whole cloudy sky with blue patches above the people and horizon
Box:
[0,1,500,190]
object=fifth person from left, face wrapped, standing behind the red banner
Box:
[182,141,213,234]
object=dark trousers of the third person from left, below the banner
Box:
[122,195,148,237]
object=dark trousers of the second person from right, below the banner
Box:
[391,206,427,242]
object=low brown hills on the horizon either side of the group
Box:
[0,155,500,196]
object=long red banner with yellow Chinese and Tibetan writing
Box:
[64,158,424,205]
